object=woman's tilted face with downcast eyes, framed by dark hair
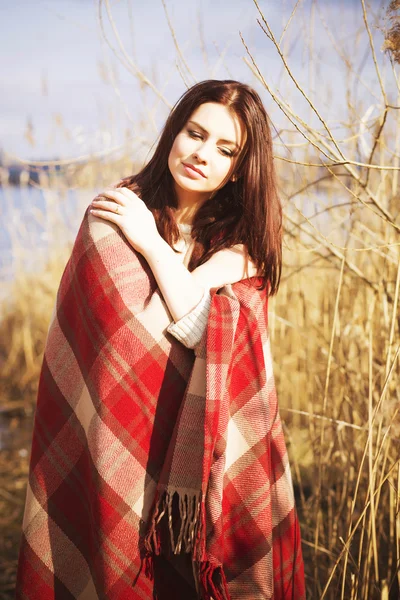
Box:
[168,102,244,205]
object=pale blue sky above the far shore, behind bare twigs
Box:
[0,0,394,159]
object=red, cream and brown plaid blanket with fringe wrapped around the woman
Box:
[17,213,305,600]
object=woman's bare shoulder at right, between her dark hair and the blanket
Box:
[193,244,257,287]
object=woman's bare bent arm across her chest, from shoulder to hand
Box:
[91,188,256,322]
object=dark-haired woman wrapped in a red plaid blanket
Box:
[17,80,304,600]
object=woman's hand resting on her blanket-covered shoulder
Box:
[90,187,160,254]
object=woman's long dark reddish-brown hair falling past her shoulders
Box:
[119,79,282,295]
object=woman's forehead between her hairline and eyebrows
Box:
[188,102,245,146]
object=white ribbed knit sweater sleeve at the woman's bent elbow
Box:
[167,289,211,349]
